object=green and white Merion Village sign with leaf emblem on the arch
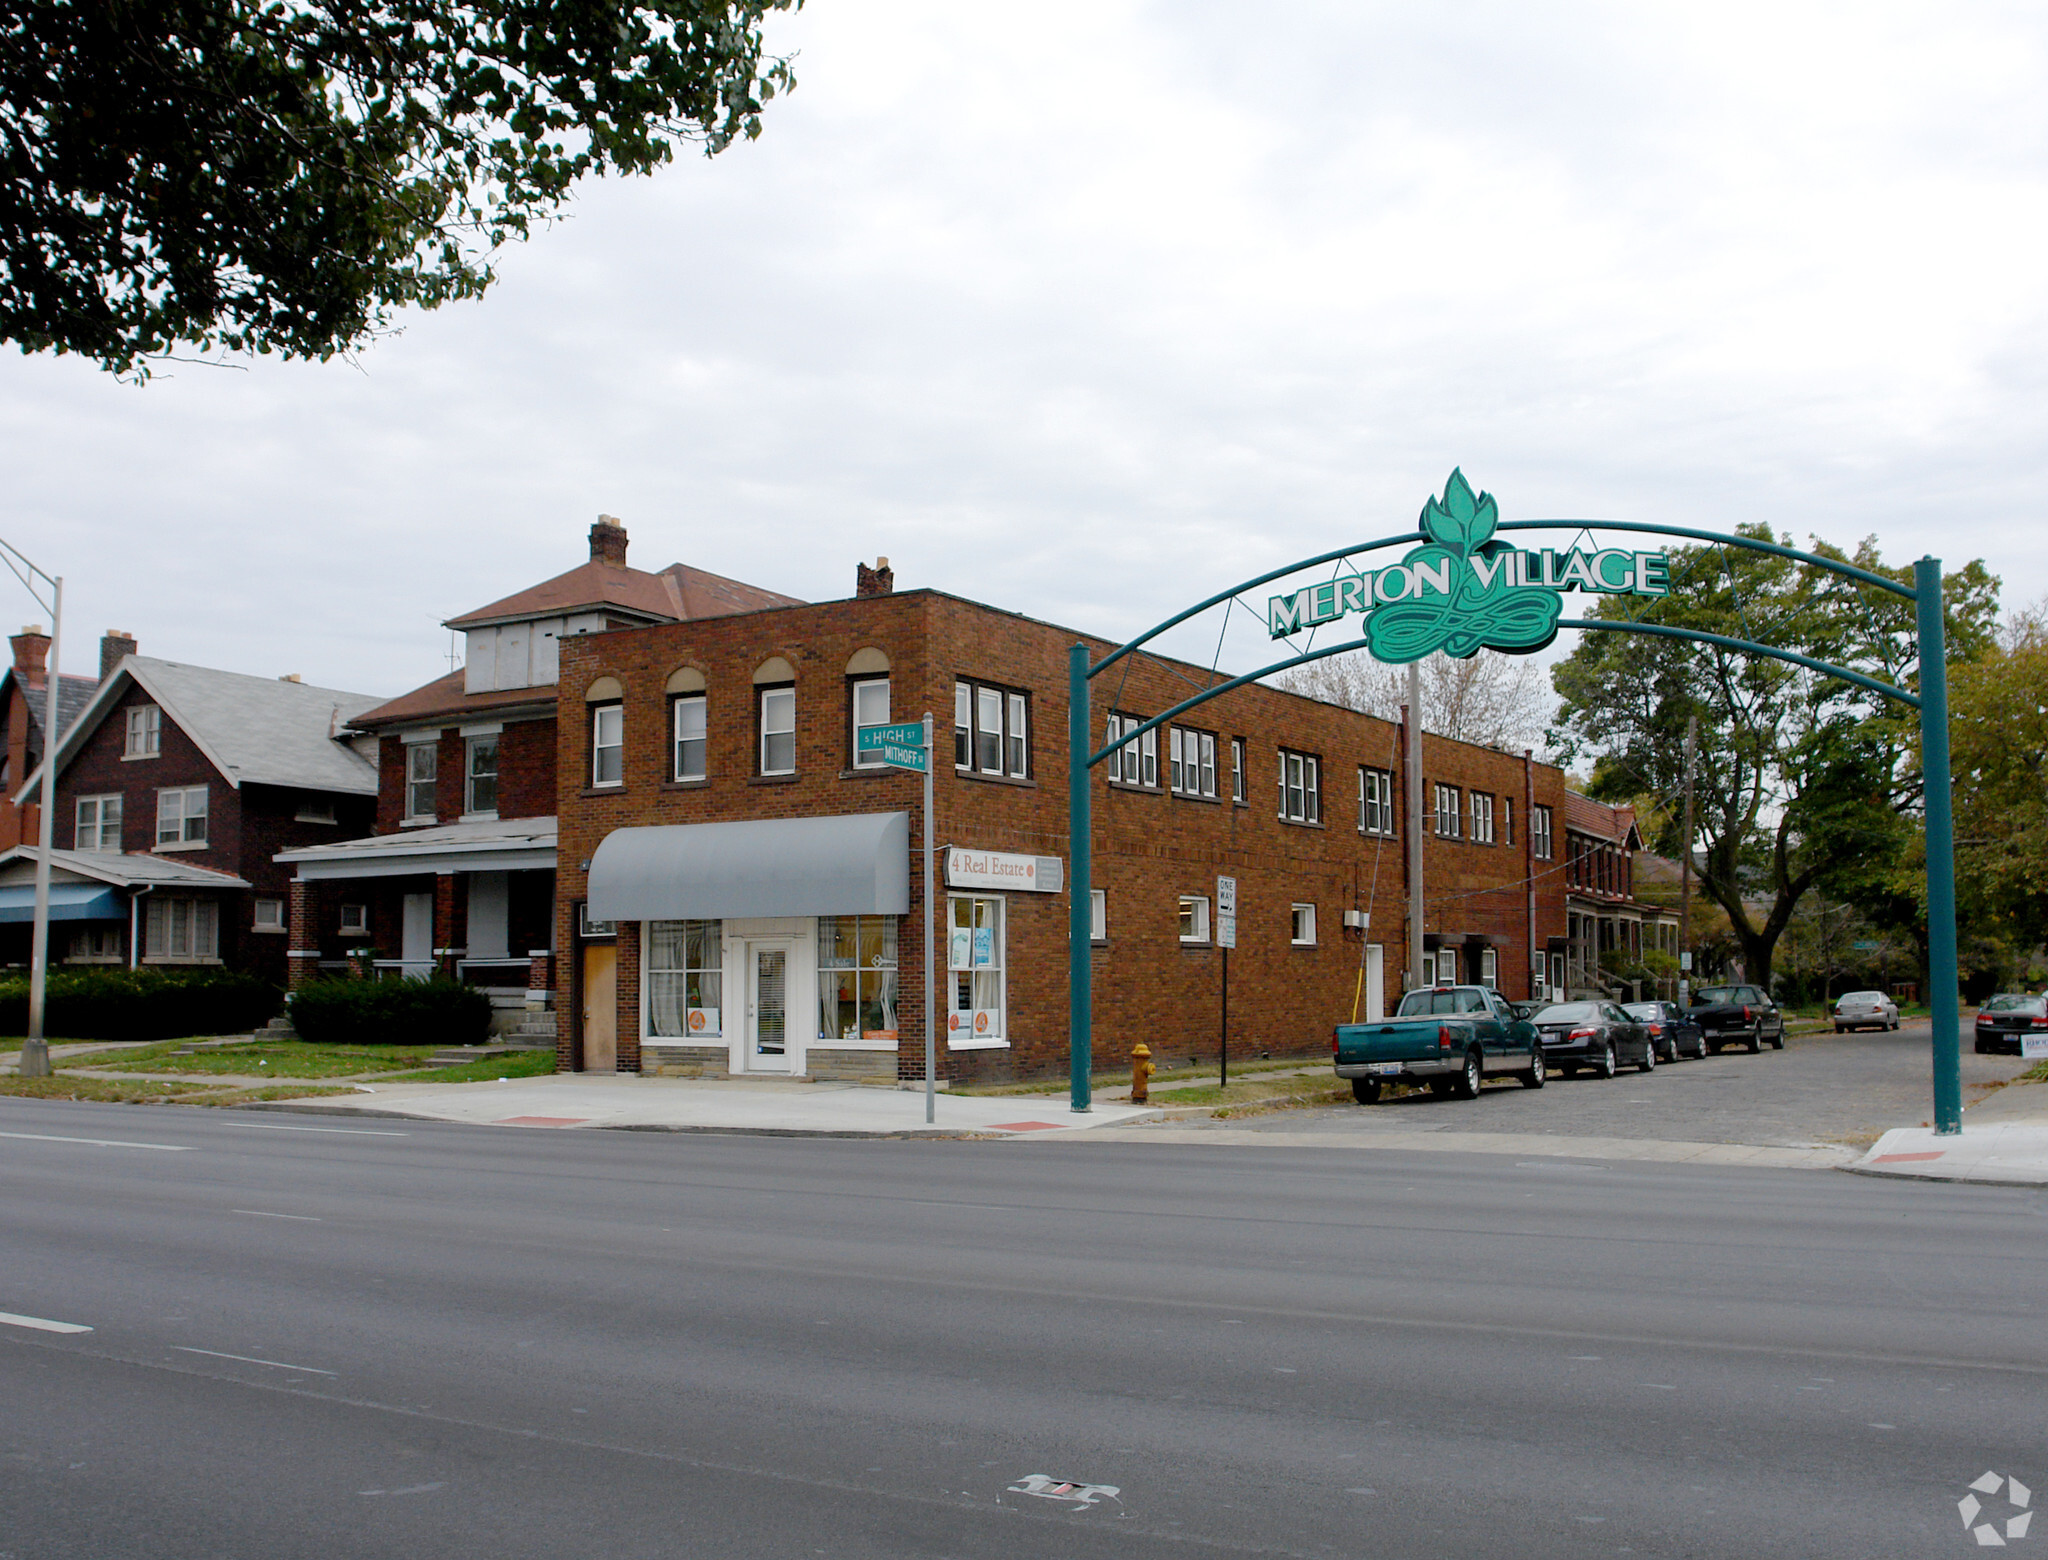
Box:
[1266,471,1671,661]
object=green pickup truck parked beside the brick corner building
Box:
[1329,987,1544,1106]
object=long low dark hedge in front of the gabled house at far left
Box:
[0,970,283,1040]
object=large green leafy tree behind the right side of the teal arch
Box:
[1552,526,1997,981]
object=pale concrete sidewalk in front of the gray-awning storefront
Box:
[242,1073,1157,1138]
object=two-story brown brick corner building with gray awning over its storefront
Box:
[555,567,1565,1083]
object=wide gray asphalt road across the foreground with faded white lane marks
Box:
[0,1099,2048,1560]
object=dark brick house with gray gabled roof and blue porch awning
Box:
[0,635,377,983]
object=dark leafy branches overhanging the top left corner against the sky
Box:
[0,0,801,379]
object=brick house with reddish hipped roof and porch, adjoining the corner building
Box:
[276,516,795,1028]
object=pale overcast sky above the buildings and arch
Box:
[0,0,2048,694]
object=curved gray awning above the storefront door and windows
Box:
[590,813,909,921]
